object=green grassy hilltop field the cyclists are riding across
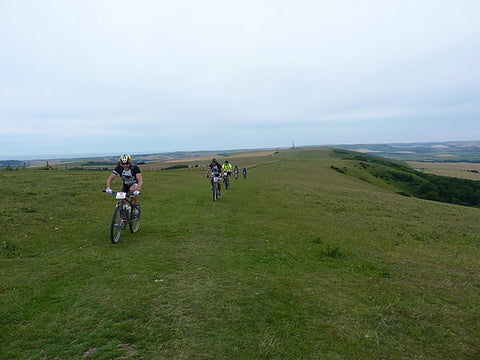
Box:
[0,149,480,360]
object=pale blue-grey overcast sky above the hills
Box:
[0,0,480,159]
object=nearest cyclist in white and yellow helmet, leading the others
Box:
[105,154,143,208]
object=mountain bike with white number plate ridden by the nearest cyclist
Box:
[103,190,140,244]
